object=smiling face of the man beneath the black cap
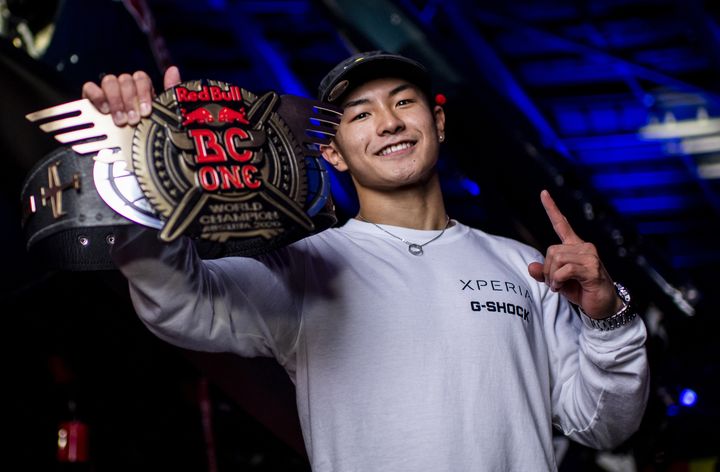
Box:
[323,78,445,194]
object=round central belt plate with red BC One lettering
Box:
[123,80,342,245]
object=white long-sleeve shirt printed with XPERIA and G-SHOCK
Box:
[113,220,648,472]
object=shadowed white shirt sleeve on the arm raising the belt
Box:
[111,227,303,364]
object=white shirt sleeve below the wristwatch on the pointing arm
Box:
[543,290,649,449]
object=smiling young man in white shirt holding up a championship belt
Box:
[84,52,648,472]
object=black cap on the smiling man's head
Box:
[318,51,430,102]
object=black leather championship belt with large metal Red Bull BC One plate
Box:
[21,80,342,270]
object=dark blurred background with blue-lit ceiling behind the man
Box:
[0,0,720,471]
